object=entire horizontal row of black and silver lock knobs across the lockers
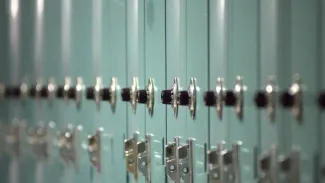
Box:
[0,74,325,120]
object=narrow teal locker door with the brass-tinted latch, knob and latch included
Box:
[121,0,147,182]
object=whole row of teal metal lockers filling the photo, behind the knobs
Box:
[0,0,325,183]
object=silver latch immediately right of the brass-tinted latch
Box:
[137,134,151,183]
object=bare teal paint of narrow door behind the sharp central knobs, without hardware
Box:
[165,0,189,182]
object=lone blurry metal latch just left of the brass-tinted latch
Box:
[88,130,101,172]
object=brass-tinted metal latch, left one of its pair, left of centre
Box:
[124,133,138,180]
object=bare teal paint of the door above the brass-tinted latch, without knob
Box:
[123,0,147,182]
